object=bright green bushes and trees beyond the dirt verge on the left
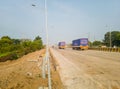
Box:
[0,36,43,61]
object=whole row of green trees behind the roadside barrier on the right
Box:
[91,31,120,47]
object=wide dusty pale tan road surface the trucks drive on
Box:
[51,48,120,89]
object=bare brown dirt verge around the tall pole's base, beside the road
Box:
[0,50,62,89]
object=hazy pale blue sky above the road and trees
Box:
[0,0,120,44]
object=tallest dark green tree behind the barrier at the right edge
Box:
[103,31,120,47]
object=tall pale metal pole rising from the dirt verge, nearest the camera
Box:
[45,0,52,89]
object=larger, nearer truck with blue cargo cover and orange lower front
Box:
[72,38,88,50]
